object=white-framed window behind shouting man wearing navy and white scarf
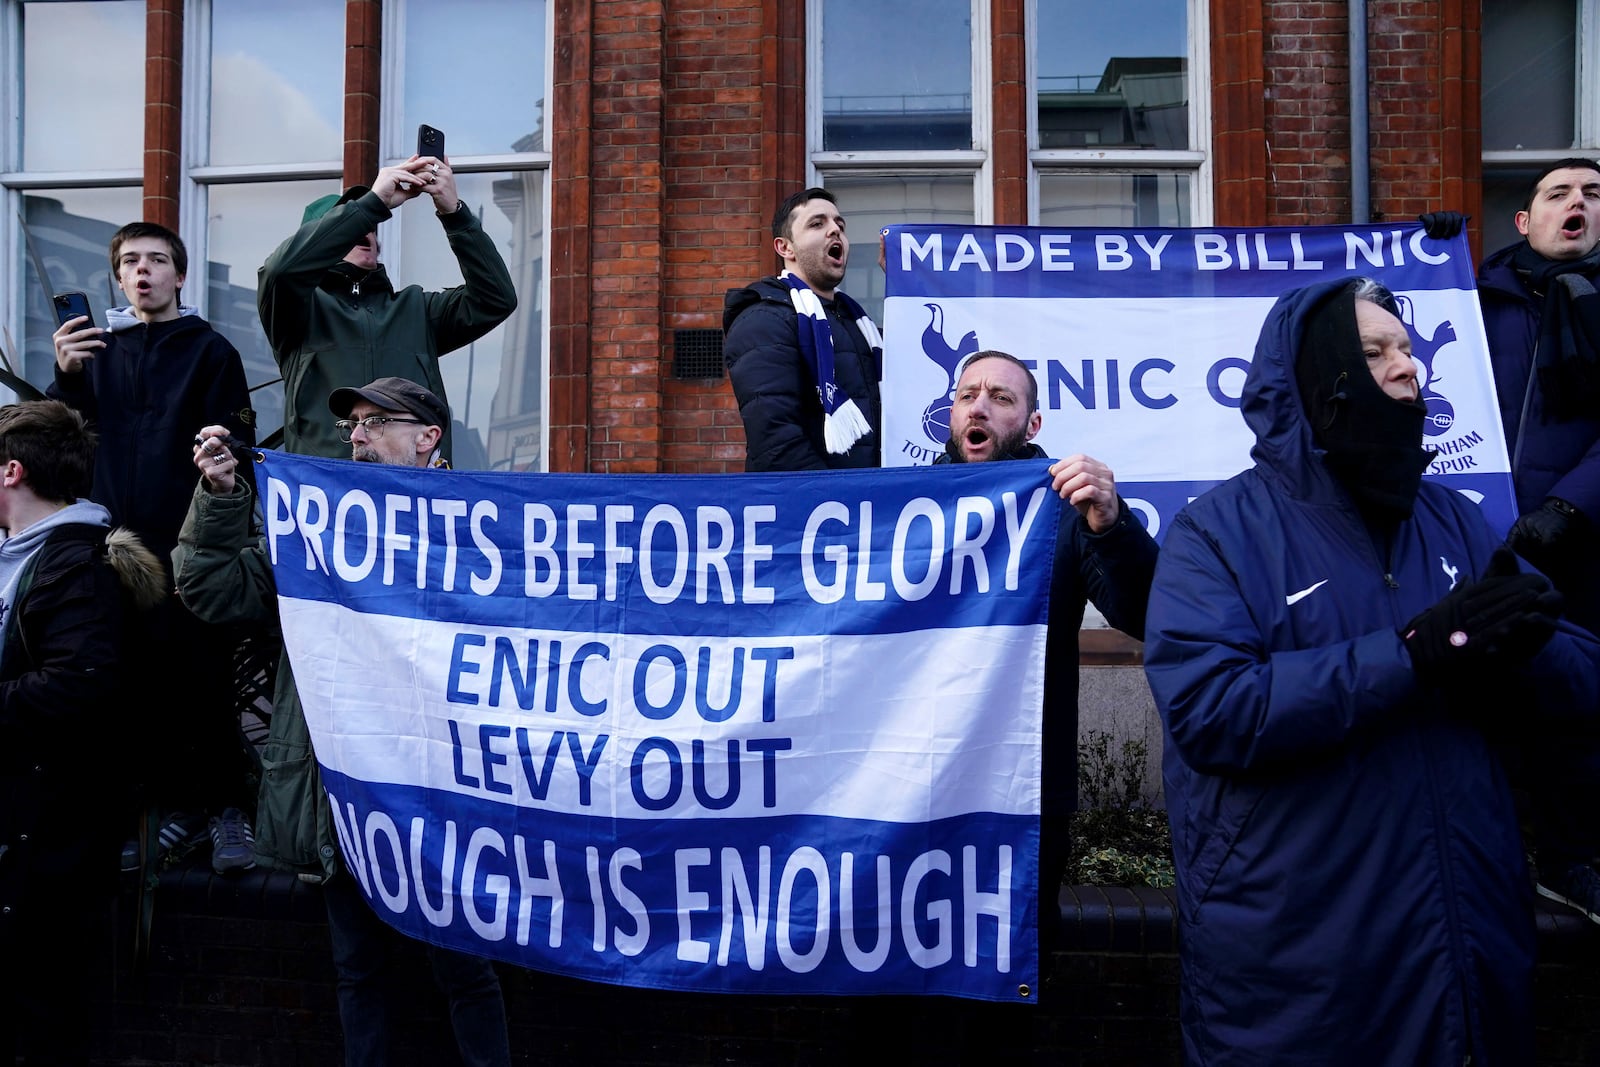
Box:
[806,0,994,322]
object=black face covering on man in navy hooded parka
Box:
[1294,291,1434,522]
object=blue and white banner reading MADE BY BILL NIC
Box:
[883,222,1515,537]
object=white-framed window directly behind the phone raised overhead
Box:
[379,0,554,470]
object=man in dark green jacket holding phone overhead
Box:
[256,126,517,458]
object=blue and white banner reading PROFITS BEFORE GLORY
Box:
[259,453,1061,1000]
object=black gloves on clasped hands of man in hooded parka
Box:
[1400,545,1562,681]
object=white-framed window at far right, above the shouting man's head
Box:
[1480,0,1600,253]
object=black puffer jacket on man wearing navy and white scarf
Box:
[722,278,883,470]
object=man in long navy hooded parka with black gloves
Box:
[1146,282,1600,1067]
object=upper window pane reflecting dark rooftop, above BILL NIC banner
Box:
[1035,0,1189,149]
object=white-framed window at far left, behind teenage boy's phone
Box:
[0,0,146,395]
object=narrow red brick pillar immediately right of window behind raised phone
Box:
[547,0,595,474]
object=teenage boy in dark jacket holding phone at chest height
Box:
[46,222,256,870]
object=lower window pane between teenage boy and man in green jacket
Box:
[206,179,339,440]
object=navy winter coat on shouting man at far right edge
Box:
[1478,245,1600,522]
